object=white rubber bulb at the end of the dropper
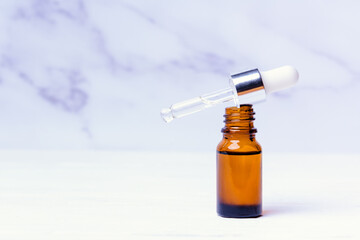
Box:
[260,66,299,94]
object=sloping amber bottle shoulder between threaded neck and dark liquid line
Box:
[216,137,262,153]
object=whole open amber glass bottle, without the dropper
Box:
[217,104,262,218]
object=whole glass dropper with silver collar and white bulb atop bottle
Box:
[160,66,299,122]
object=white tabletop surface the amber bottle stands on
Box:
[0,151,360,240]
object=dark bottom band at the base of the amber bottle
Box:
[217,203,262,218]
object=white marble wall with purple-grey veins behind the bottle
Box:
[0,0,360,153]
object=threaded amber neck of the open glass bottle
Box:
[221,104,257,138]
